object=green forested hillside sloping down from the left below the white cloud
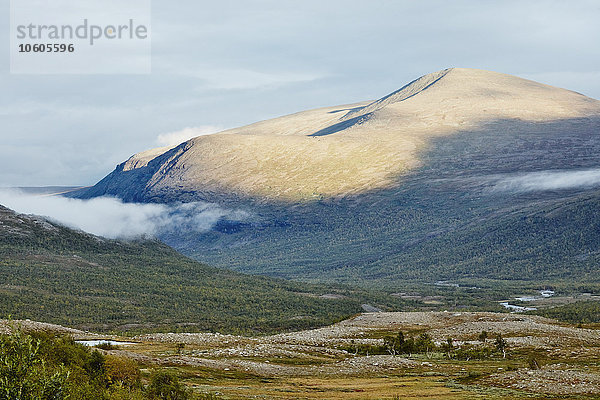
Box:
[0,206,363,332]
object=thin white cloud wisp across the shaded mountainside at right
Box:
[492,169,600,192]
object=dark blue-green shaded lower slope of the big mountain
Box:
[158,118,600,285]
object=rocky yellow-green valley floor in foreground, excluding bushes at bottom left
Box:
[4,312,600,399]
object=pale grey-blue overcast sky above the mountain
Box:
[0,0,600,186]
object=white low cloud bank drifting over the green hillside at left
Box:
[0,190,250,239]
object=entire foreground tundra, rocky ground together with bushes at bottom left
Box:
[0,312,600,400]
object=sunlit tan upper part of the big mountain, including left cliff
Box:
[77,68,600,201]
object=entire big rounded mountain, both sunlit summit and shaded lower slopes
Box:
[78,68,600,285]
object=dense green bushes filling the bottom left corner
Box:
[0,328,150,400]
